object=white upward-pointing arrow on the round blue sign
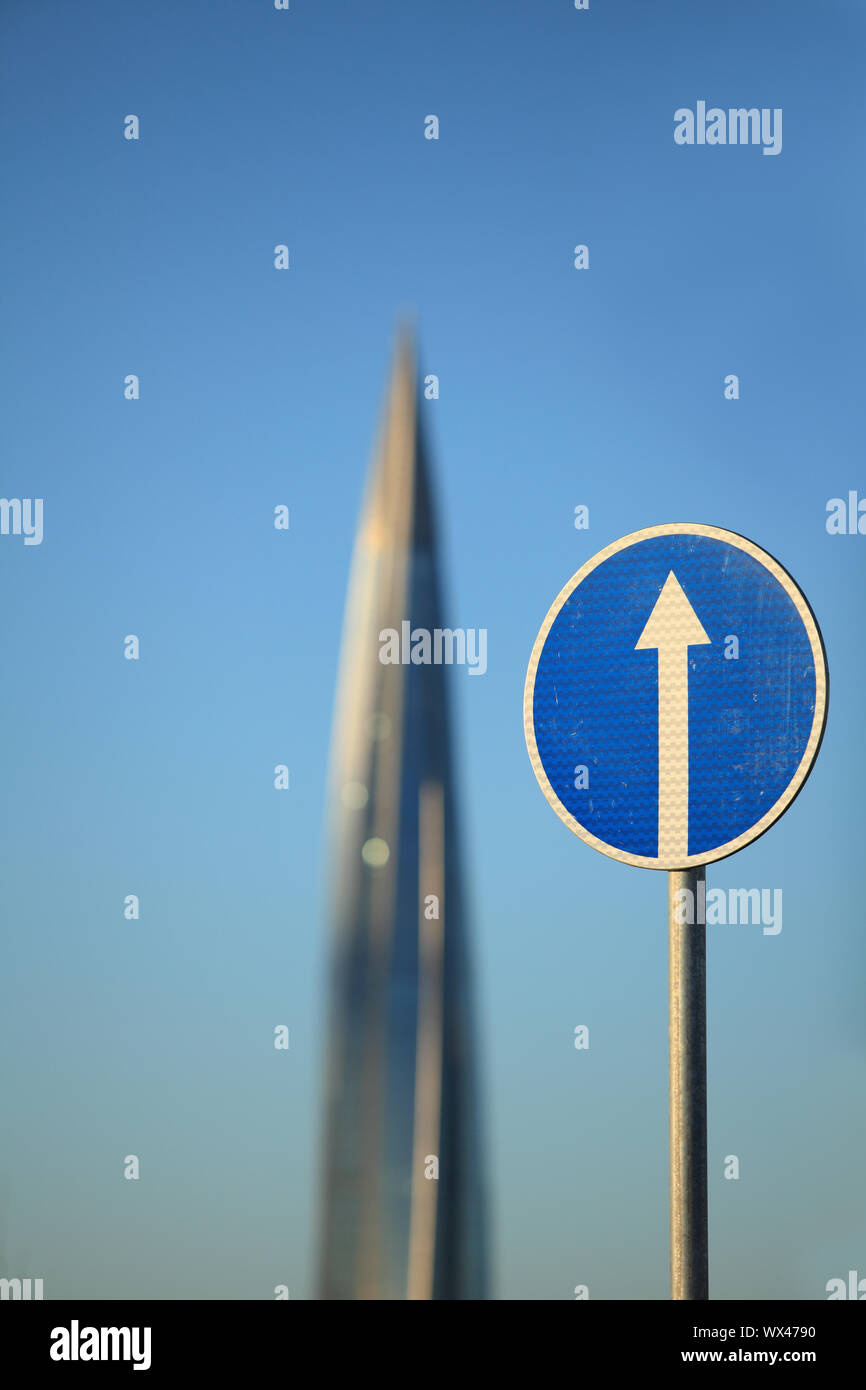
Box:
[635,570,710,867]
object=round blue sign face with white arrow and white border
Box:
[524,524,827,869]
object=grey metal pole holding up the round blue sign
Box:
[667,866,709,1298]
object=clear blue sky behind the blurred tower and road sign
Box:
[0,0,866,1300]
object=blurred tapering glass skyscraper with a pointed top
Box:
[320,334,487,1300]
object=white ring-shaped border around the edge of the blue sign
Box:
[523,521,828,869]
